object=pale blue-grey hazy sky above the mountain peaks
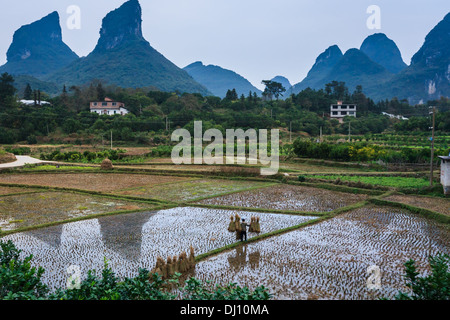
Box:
[0,0,450,88]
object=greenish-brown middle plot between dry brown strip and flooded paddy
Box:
[114,179,268,201]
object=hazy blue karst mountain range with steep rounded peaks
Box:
[0,0,450,104]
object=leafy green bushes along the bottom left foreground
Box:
[0,241,272,300]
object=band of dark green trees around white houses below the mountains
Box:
[0,73,450,145]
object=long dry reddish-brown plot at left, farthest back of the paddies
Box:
[0,173,189,192]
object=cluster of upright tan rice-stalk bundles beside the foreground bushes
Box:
[150,246,195,279]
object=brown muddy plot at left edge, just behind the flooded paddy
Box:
[0,192,155,231]
